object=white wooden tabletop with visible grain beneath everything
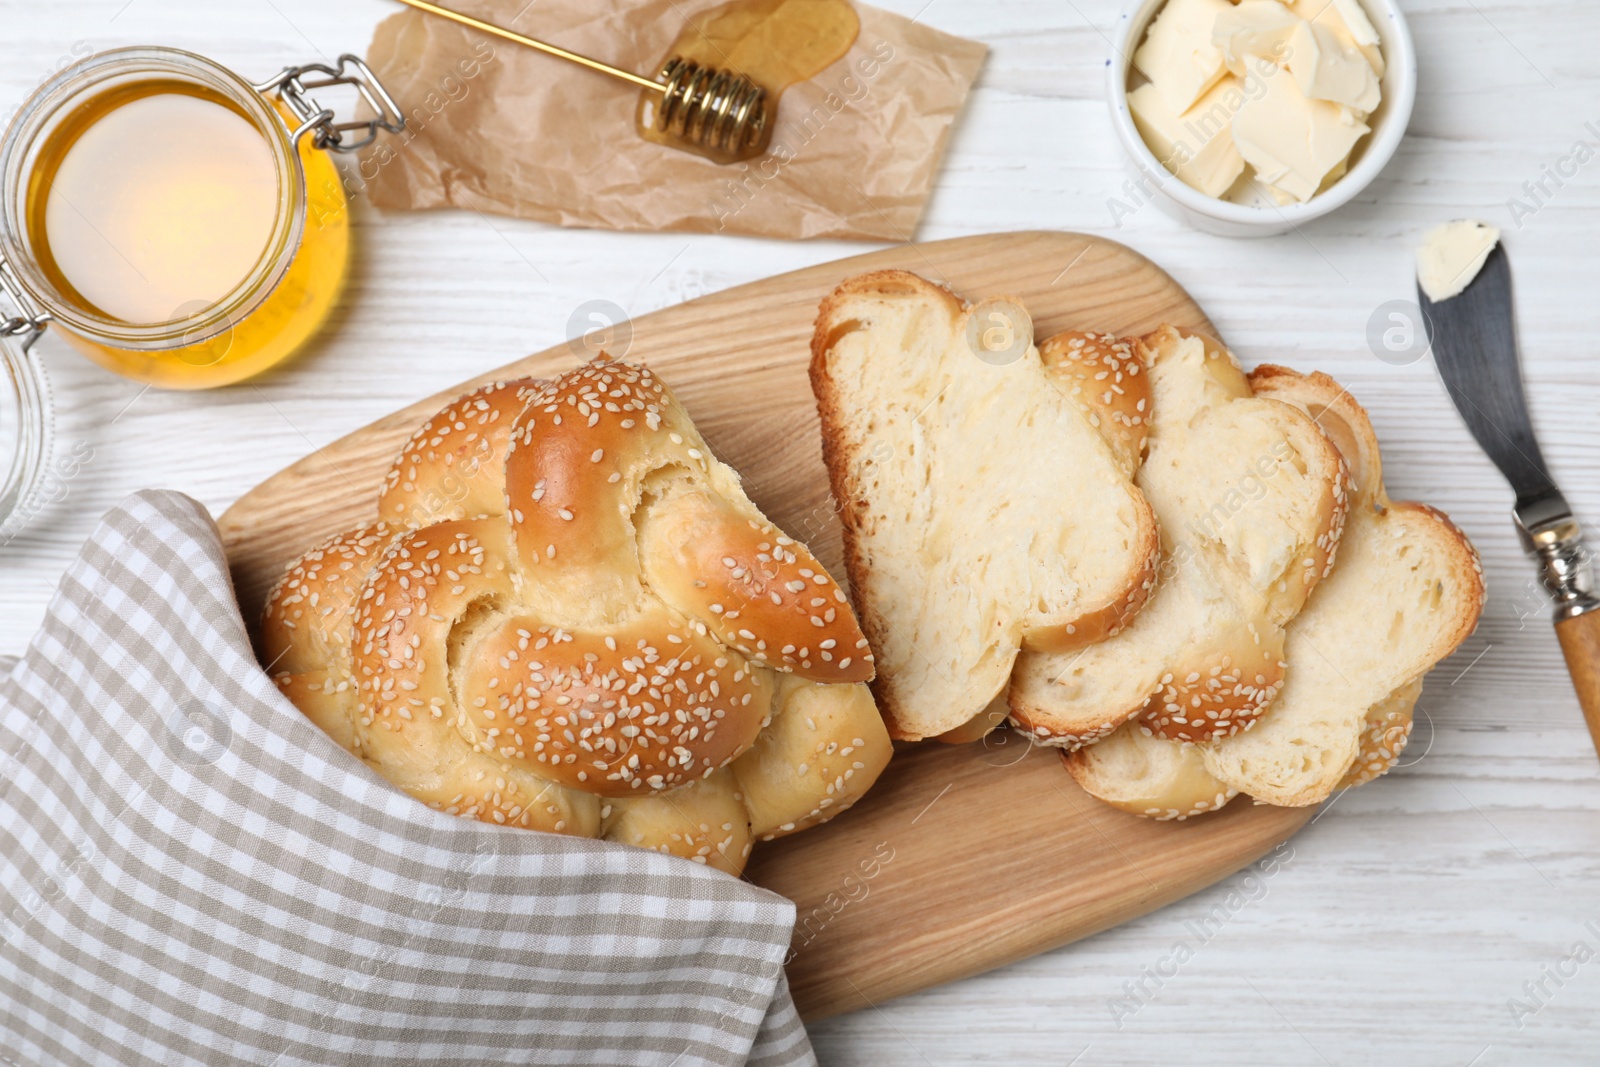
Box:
[0,0,1600,1067]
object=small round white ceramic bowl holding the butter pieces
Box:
[1106,0,1416,237]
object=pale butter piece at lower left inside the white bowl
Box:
[1128,77,1241,197]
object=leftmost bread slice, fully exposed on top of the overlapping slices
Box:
[811,270,1158,741]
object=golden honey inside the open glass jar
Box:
[26,78,349,389]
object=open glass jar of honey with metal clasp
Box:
[0,48,405,389]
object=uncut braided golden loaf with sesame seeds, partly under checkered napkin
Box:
[262,362,890,873]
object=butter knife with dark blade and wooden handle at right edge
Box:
[1418,245,1600,750]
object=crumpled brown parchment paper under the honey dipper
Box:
[358,0,987,240]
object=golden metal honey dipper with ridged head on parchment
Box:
[390,0,768,158]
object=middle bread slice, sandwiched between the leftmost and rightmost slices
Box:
[1010,326,1347,749]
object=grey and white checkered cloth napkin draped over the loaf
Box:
[0,493,814,1067]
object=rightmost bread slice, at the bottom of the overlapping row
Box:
[1064,366,1485,819]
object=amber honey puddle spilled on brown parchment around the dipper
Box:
[634,0,861,163]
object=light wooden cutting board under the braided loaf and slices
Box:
[221,232,1312,1019]
